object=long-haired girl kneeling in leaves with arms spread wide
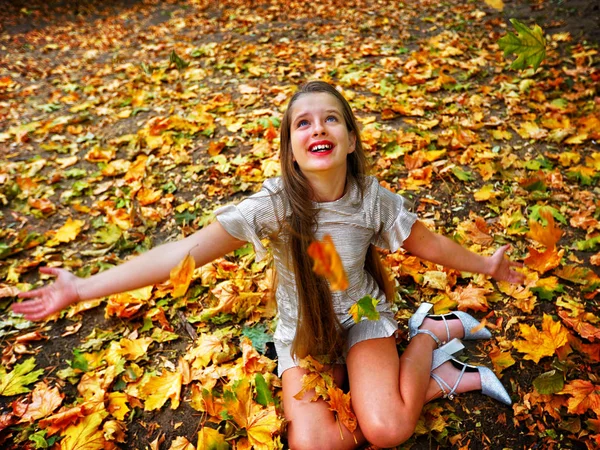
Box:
[13,81,523,449]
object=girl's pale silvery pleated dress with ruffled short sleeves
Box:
[215,177,417,376]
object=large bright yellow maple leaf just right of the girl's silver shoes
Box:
[513,314,569,363]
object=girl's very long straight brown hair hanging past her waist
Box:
[280,81,395,361]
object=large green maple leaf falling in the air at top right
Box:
[498,19,546,69]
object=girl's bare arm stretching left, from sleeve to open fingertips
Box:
[13,221,244,320]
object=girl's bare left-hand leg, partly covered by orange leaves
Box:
[282,365,365,450]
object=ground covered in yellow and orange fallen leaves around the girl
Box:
[0,0,600,449]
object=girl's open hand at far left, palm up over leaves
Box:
[12,267,80,320]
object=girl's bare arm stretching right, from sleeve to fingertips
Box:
[402,221,525,283]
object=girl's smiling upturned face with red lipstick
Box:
[290,92,356,176]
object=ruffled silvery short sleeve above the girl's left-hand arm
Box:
[214,179,283,261]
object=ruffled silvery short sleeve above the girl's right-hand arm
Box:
[373,183,418,252]
